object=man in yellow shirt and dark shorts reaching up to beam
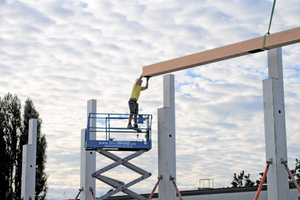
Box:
[127,75,149,129]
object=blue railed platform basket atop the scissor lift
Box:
[85,113,152,151]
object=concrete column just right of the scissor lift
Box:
[157,75,177,200]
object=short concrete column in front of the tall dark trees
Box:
[21,119,37,200]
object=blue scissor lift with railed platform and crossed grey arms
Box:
[85,113,152,200]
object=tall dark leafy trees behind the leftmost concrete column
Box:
[0,93,48,200]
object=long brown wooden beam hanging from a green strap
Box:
[143,27,300,77]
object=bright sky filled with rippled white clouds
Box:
[0,0,300,199]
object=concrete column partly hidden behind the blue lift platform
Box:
[80,99,97,200]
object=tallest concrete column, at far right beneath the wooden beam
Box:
[263,48,289,200]
